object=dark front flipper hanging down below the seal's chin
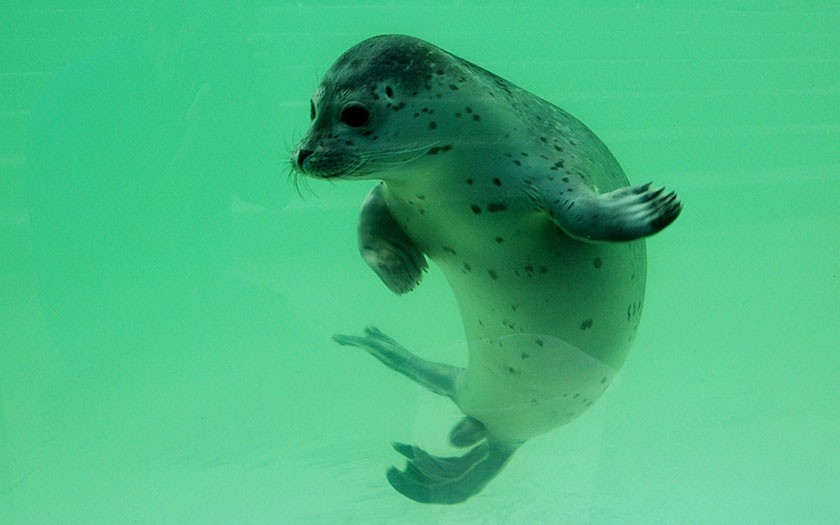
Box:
[358,184,429,294]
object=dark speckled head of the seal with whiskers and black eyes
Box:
[292,35,488,179]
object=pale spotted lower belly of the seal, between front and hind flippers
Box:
[435,221,645,441]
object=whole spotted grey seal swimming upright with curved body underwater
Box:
[291,35,682,504]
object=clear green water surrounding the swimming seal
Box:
[0,0,840,525]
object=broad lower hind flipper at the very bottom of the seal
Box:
[388,440,519,505]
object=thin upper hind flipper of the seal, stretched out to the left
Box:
[333,327,463,399]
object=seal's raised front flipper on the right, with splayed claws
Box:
[528,178,682,241]
